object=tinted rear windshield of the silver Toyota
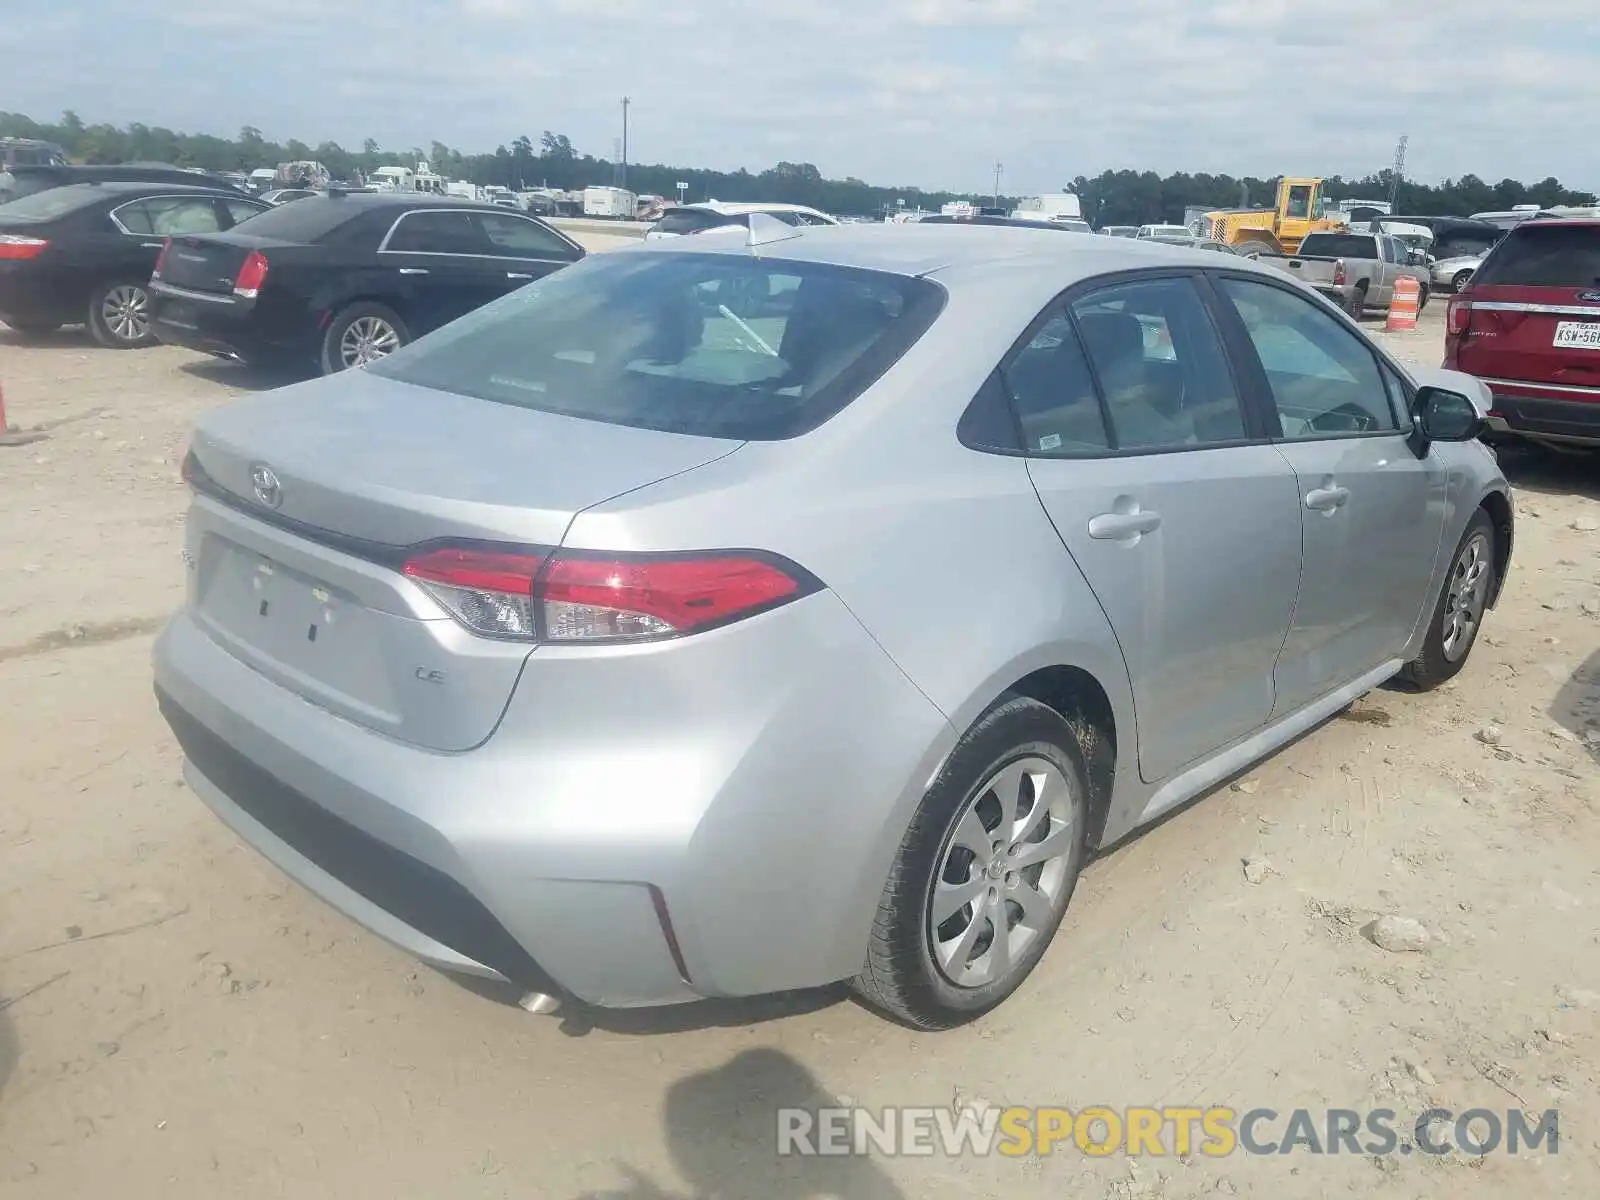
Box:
[368,253,944,442]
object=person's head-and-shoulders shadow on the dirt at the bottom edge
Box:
[578,1048,904,1200]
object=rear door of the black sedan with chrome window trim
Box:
[378,208,506,336]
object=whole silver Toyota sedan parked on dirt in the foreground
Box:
[155,219,1512,1027]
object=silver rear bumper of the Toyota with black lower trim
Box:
[155,592,954,1006]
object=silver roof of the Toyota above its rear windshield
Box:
[636,221,1283,291]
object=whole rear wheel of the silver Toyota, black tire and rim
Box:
[853,694,1088,1029]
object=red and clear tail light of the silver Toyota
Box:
[402,546,821,642]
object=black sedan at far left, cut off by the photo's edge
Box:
[0,182,267,349]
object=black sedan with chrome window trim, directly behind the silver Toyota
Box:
[150,190,584,374]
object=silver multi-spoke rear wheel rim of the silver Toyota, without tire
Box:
[926,755,1077,987]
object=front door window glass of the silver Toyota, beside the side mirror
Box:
[1219,278,1400,442]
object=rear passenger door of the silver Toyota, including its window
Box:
[1002,275,1301,782]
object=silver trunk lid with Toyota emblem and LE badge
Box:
[187,371,742,750]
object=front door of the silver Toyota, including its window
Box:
[1218,277,1446,714]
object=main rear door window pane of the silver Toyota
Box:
[1072,278,1246,450]
